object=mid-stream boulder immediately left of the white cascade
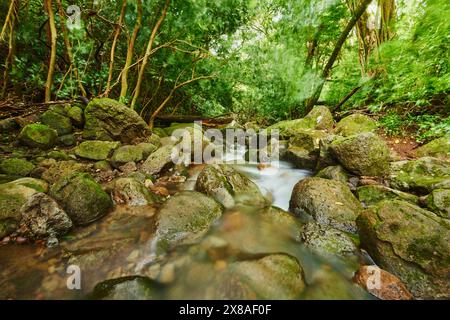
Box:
[195,165,267,208]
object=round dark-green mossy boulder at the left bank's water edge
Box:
[50,173,113,225]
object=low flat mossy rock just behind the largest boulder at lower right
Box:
[357,185,419,206]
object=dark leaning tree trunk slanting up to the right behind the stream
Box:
[304,0,372,114]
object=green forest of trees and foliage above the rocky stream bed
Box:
[0,0,450,139]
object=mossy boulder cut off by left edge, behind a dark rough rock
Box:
[0,178,48,239]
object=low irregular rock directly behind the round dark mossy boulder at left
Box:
[39,159,89,184]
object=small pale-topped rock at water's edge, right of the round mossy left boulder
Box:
[111,178,157,206]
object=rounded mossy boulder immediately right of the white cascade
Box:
[289,178,362,232]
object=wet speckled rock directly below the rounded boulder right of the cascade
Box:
[301,221,358,267]
